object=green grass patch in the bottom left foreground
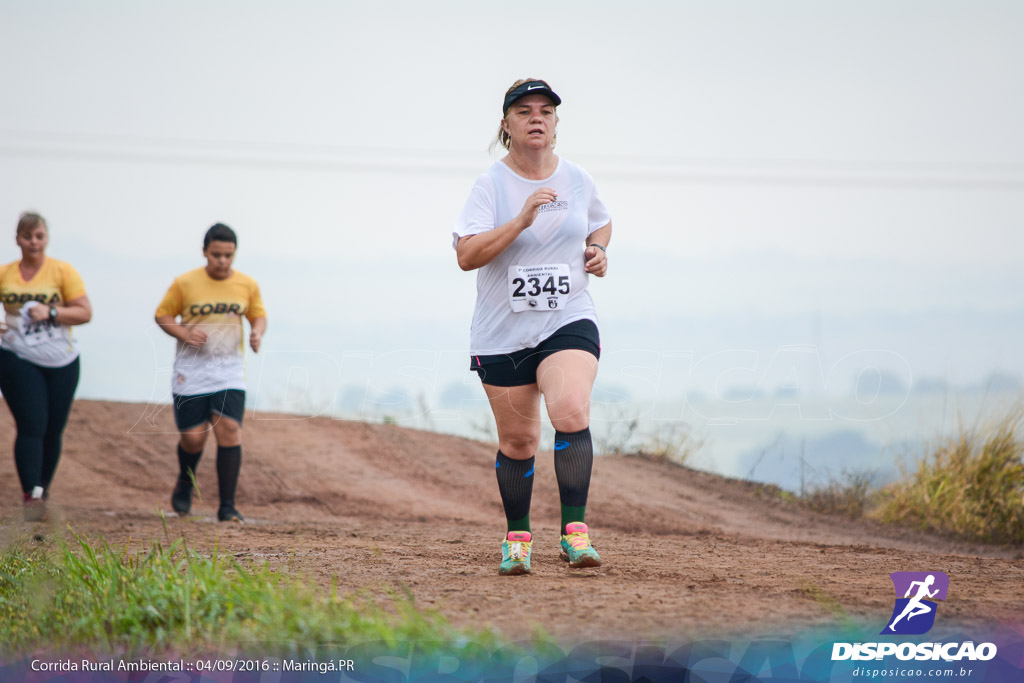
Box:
[0,537,495,655]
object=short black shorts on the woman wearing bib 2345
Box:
[469,319,601,387]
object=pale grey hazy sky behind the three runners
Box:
[0,0,1024,411]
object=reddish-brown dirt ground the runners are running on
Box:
[0,400,1024,642]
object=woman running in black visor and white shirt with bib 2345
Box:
[454,79,611,574]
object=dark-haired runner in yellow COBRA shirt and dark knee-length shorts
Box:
[157,223,266,522]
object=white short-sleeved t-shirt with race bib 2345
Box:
[452,158,610,355]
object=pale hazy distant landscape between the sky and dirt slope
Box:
[59,390,1024,493]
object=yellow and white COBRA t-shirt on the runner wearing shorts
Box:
[157,267,266,396]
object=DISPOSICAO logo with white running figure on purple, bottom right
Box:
[831,571,996,661]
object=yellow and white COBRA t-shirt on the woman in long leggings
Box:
[0,257,85,368]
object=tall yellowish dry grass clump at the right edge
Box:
[871,408,1024,544]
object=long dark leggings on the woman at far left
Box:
[0,349,79,494]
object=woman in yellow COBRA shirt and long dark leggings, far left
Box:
[0,213,92,521]
